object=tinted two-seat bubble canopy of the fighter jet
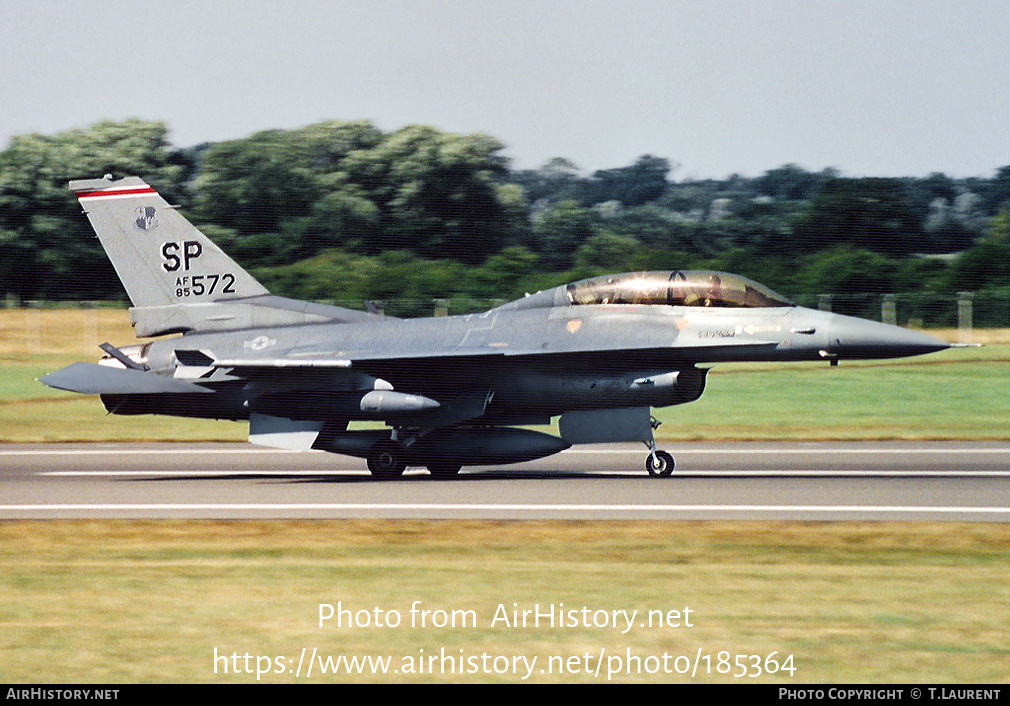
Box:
[562,270,795,308]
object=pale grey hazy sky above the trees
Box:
[0,0,1010,179]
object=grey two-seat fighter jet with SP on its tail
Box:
[41,176,948,479]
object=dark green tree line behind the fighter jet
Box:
[0,120,1010,321]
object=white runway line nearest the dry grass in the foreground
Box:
[0,503,1010,515]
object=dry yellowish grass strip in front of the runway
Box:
[0,520,1010,683]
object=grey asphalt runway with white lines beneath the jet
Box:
[0,442,1010,522]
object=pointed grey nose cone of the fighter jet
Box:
[828,314,950,359]
